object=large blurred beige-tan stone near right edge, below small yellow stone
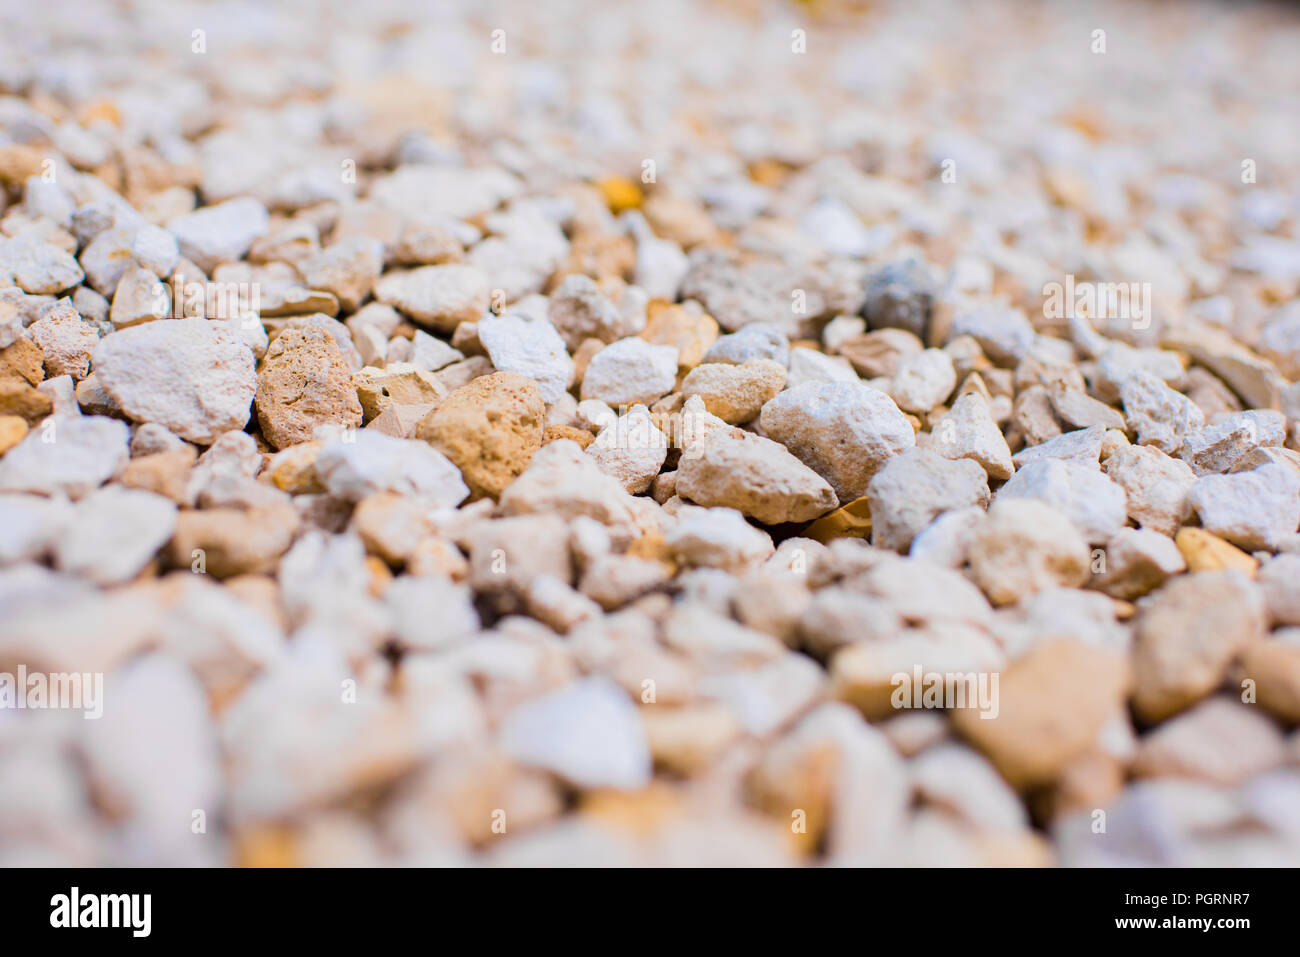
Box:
[1132,571,1268,723]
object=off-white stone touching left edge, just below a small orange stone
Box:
[0,416,130,499]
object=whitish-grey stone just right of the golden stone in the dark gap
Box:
[867,449,989,553]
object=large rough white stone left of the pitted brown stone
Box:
[94,319,259,445]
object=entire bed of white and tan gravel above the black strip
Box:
[0,0,1300,865]
